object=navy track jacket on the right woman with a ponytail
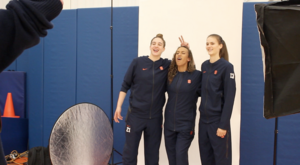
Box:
[199,58,236,130]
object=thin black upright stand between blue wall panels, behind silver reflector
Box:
[109,0,123,165]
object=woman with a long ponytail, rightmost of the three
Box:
[199,34,236,165]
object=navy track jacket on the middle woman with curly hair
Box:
[164,70,201,131]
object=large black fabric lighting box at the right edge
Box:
[255,1,300,119]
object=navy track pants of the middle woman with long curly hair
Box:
[164,129,194,165]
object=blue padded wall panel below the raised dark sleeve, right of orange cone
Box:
[17,38,44,149]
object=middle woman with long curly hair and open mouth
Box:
[164,46,201,165]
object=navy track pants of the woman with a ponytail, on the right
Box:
[199,121,231,165]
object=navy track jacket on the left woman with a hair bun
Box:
[121,56,170,119]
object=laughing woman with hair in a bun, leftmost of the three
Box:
[114,34,170,165]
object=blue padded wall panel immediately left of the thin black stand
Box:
[76,8,111,118]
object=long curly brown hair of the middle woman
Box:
[168,46,196,84]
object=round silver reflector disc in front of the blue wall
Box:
[49,103,113,165]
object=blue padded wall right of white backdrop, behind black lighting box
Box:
[240,3,300,165]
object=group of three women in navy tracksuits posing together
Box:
[114,34,236,165]
